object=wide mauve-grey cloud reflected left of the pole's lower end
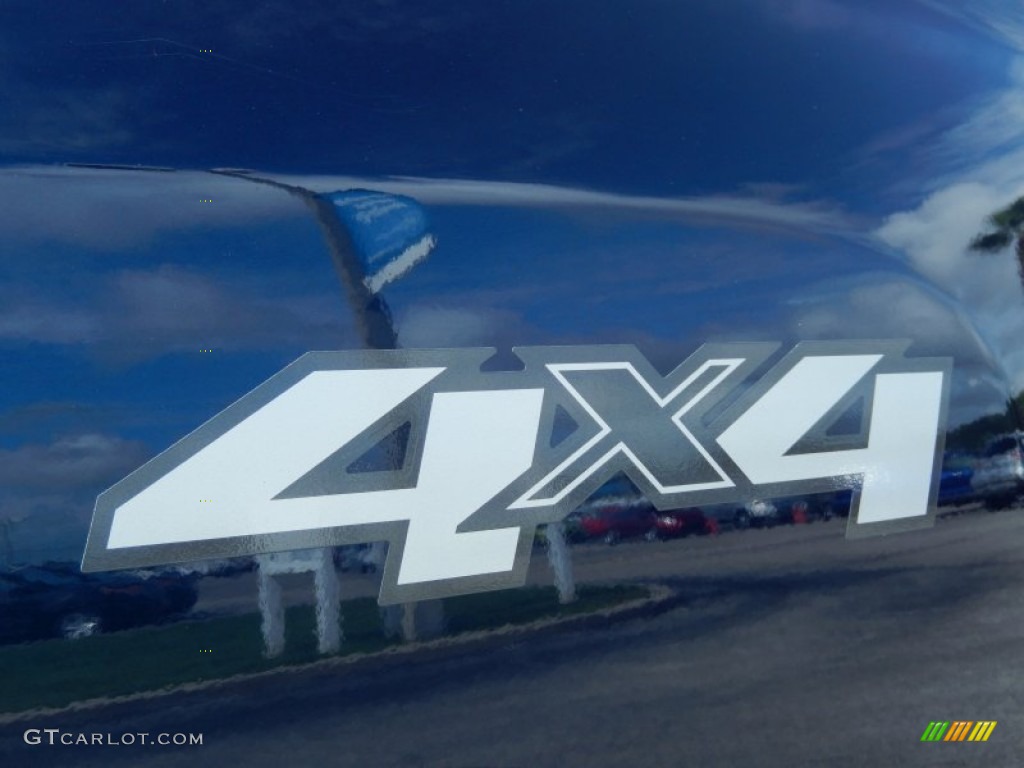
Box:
[0,265,354,361]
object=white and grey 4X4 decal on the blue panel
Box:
[83,342,951,602]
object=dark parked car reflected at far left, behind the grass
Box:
[0,562,199,643]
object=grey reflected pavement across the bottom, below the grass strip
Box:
[6,511,1024,768]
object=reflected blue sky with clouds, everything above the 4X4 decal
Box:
[0,0,1024,555]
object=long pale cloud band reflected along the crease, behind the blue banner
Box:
[0,167,857,248]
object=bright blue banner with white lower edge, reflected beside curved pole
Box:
[321,189,436,293]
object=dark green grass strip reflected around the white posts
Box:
[0,587,648,713]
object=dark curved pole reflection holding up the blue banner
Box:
[211,169,443,651]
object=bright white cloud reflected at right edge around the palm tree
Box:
[876,6,1024,397]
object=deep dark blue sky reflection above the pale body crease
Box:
[0,0,1010,203]
